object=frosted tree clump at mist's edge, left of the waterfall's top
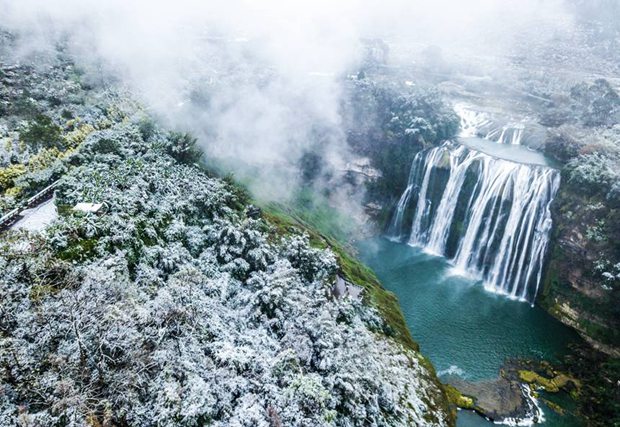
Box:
[345,77,459,205]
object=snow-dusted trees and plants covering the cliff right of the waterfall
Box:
[539,109,620,354]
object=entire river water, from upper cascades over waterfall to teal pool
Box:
[359,105,579,427]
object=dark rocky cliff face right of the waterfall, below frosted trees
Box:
[539,180,620,357]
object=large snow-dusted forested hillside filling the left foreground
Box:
[0,51,453,426]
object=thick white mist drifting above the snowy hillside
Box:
[0,0,573,200]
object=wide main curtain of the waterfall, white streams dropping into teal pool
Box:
[388,142,560,302]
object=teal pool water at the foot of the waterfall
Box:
[358,237,579,427]
